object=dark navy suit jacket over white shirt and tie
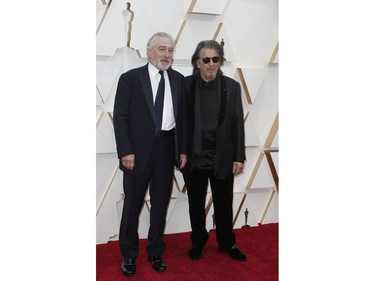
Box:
[113,64,187,175]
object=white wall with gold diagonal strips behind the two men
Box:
[96,0,278,244]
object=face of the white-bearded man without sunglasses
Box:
[147,37,174,70]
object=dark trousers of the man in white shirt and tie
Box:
[119,134,175,259]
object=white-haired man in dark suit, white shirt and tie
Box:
[113,32,187,276]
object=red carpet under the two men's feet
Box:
[96,223,278,281]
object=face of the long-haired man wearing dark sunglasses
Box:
[197,48,220,82]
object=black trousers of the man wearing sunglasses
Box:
[184,169,235,249]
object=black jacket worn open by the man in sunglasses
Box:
[183,74,246,178]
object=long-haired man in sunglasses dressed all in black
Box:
[183,40,246,261]
